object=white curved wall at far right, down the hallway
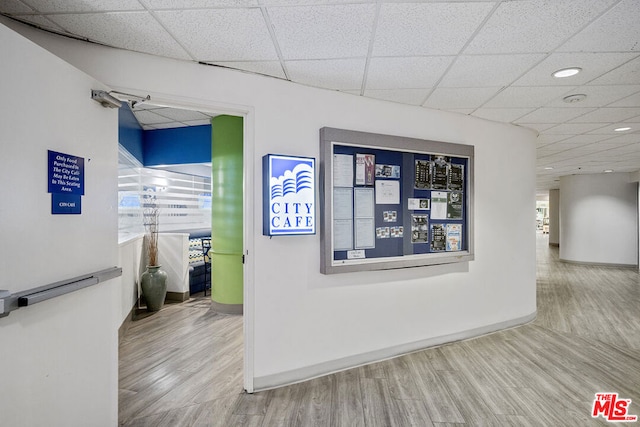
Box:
[560,173,638,265]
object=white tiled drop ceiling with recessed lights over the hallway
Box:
[0,0,640,192]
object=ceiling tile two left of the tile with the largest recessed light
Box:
[367,56,452,89]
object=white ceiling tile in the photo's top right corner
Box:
[558,0,640,52]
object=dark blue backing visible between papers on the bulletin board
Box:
[333,144,469,261]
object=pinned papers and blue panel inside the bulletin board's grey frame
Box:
[331,143,469,260]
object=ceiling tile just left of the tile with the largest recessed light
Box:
[440,54,544,87]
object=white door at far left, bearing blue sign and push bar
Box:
[0,25,118,426]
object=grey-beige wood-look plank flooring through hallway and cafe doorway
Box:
[119,234,640,427]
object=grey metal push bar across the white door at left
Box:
[0,267,122,317]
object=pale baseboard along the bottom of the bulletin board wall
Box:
[253,311,537,392]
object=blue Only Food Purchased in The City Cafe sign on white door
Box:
[47,150,84,215]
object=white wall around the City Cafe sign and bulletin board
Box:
[6,20,536,392]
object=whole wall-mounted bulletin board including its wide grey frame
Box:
[320,128,474,274]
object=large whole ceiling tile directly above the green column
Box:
[156,9,278,62]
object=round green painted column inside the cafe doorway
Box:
[211,116,244,313]
